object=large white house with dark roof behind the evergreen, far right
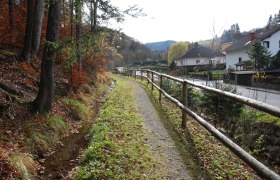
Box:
[226,26,280,70]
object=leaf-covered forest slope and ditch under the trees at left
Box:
[0,49,109,179]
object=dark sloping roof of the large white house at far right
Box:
[226,26,280,52]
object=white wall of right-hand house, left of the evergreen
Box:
[226,51,250,69]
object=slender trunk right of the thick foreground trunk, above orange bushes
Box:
[76,0,82,72]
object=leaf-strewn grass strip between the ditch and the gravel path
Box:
[75,76,154,179]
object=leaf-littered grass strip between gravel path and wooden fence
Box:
[135,76,259,179]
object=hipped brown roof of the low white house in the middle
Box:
[178,45,225,59]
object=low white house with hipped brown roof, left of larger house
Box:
[175,44,225,67]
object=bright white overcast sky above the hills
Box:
[109,0,280,43]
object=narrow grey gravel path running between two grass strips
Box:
[132,82,192,179]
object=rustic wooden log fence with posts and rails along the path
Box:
[129,70,280,180]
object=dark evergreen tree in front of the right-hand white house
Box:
[248,41,271,70]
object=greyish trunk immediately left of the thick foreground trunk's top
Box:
[31,0,45,54]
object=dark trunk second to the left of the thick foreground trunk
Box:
[21,0,34,63]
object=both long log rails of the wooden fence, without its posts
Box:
[132,70,280,180]
